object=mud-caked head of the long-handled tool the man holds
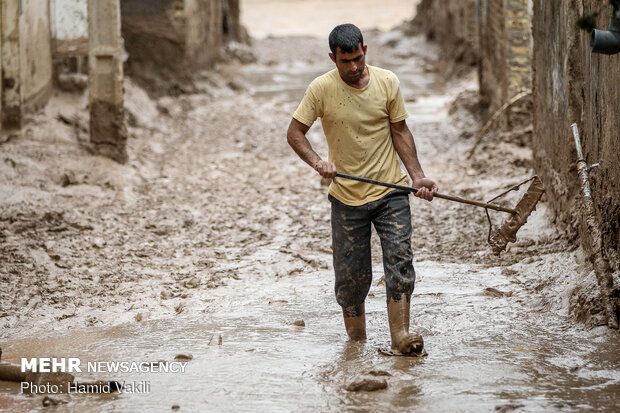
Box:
[489,176,545,255]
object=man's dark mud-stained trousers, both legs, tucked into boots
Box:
[329,191,415,318]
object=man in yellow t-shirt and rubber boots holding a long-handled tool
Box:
[287,24,437,355]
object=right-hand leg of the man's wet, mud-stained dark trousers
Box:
[373,194,415,302]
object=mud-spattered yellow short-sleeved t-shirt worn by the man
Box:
[293,65,409,206]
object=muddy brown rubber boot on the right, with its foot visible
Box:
[388,295,424,355]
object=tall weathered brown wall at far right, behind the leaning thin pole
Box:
[533,0,620,271]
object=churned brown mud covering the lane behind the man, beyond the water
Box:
[0,33,600,337]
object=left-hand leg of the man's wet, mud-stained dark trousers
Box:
[329,196,372,318]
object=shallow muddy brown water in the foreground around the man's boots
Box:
[0,262,620,412]
